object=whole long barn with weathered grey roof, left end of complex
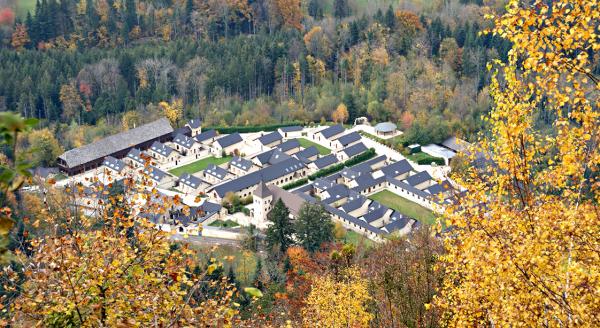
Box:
[58,118,173,175]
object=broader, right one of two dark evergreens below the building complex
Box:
[296,202,334,253]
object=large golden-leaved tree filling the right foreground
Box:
[439,0,600,327]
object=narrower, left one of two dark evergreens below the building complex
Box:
[267,199,294,253]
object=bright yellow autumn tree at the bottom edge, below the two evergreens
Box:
[302,267,373,328]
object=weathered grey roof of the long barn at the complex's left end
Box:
[59,118,173,167]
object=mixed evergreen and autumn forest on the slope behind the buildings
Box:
[0,0,510,160]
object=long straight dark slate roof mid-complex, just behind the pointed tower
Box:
[214,158,304,197]
